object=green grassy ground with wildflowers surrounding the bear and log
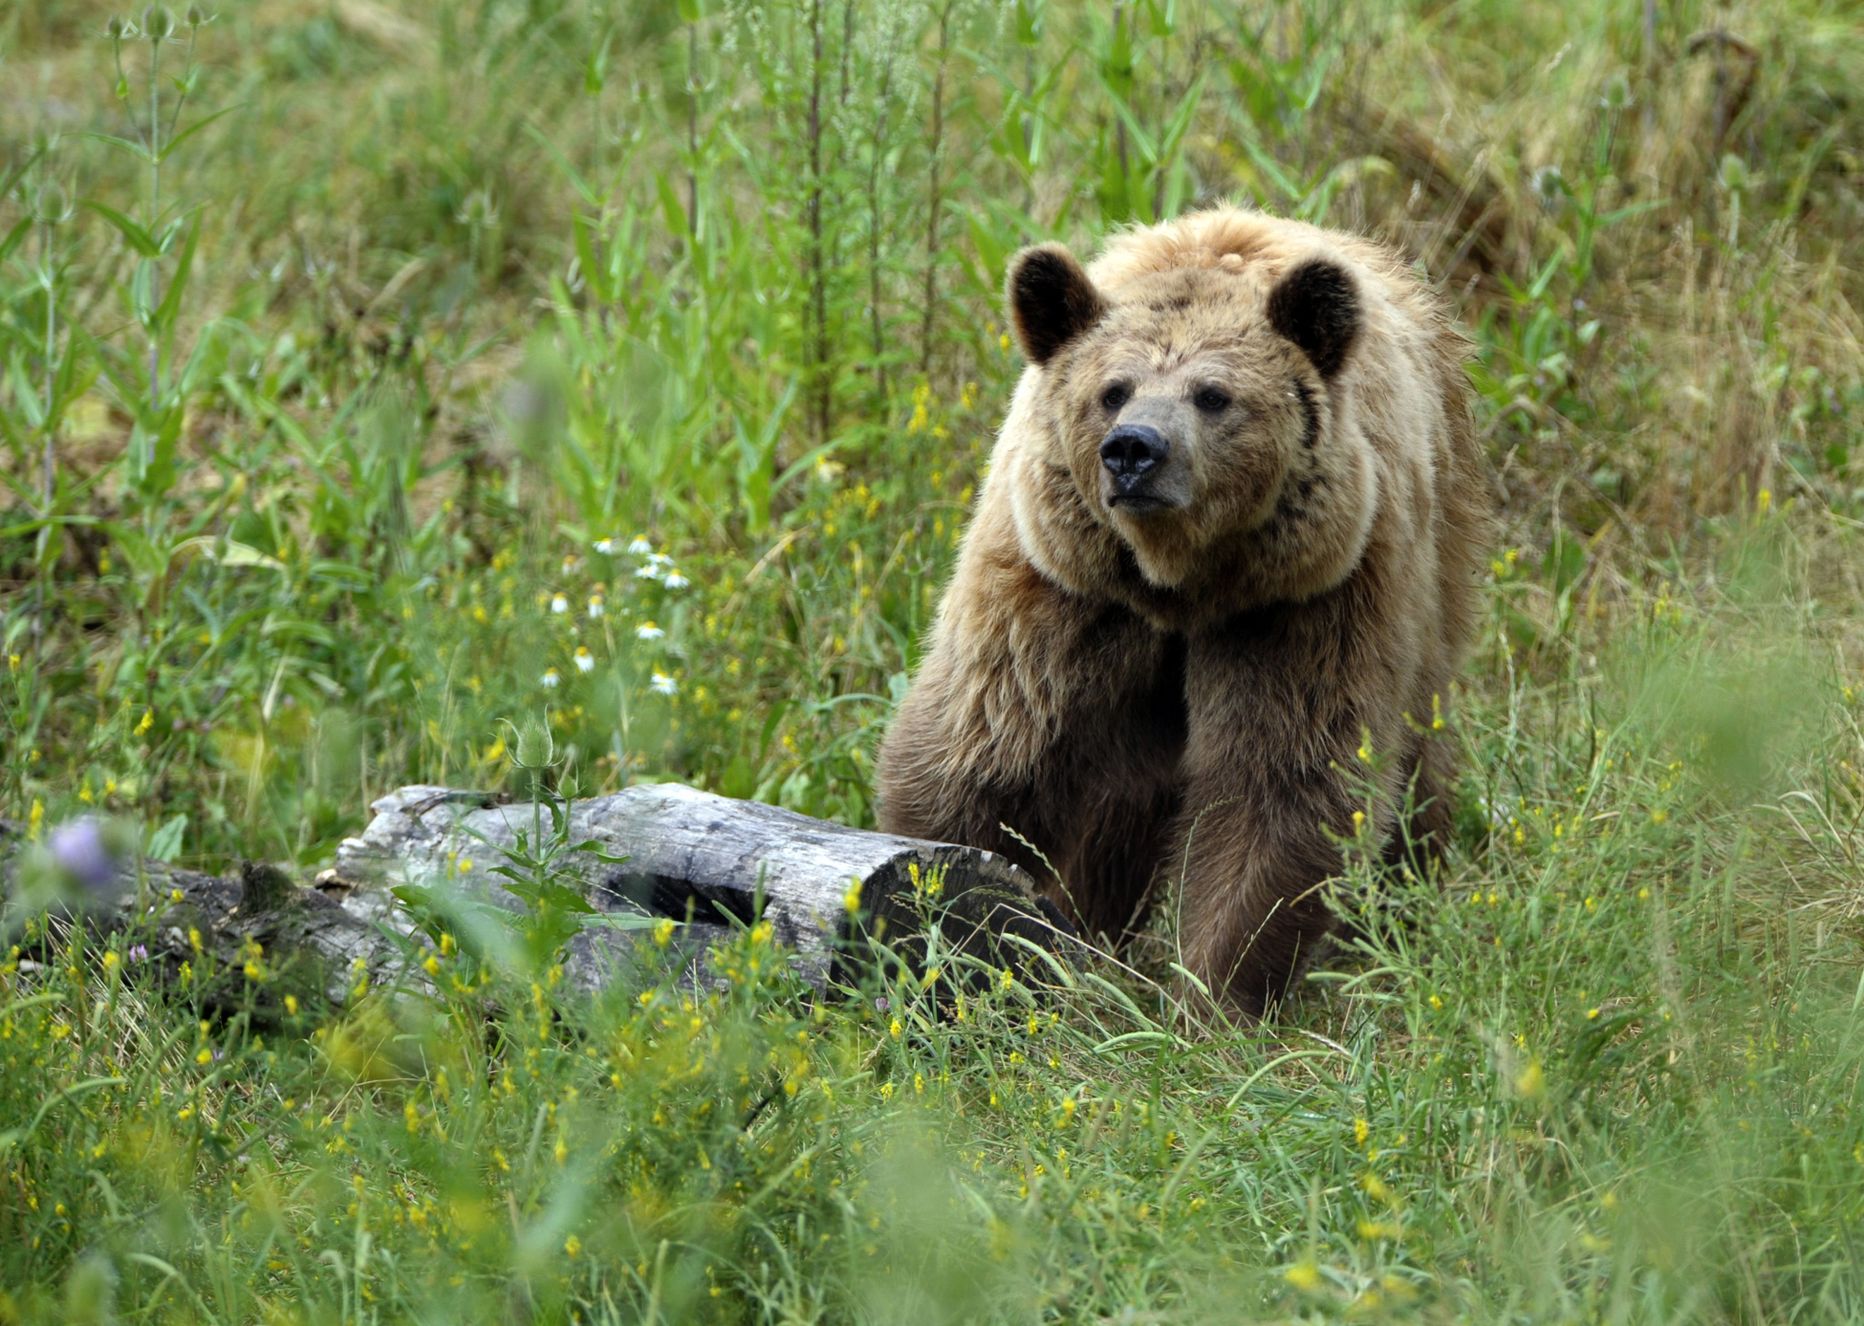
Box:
[0,0,1864,1322]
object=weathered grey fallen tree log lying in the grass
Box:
[0,783,1061,1000]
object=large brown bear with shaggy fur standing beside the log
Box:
[878,207,1489,1015]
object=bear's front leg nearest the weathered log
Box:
[878,565,1182,940]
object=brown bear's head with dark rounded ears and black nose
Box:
[1008,235,1377,617]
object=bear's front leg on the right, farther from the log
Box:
[1163,604,1400,1016]
